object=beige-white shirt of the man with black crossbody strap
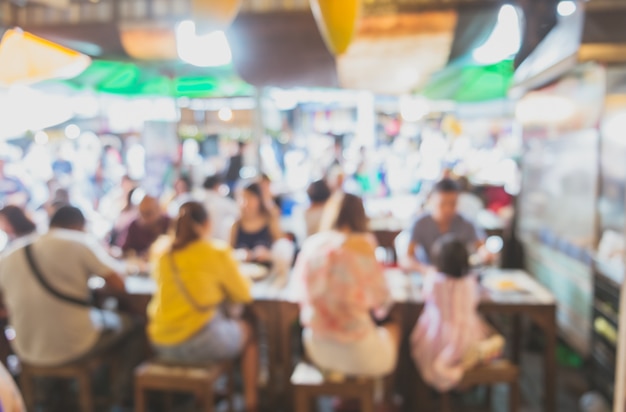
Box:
[0,229,123,366]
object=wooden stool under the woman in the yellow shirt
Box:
[135,362,234,412]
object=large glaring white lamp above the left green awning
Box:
[176,20,233,67]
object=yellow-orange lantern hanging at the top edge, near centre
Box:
[311,0,361,55]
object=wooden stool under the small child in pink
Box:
[441,360,520,412]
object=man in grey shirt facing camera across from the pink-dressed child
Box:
[406,179,484,273]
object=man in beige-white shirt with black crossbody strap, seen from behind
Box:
[0,206,141,405]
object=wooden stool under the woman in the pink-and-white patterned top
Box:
[291,363,376,412]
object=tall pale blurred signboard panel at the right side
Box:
[517,64,606,355]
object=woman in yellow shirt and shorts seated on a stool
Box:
[148,202,259,411]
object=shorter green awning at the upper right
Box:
[420,59,515,103]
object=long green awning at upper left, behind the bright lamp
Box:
[54,60,253,98]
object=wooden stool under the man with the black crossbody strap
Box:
[20,357,106,412]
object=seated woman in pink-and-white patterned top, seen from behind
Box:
[294,194,400,377]
